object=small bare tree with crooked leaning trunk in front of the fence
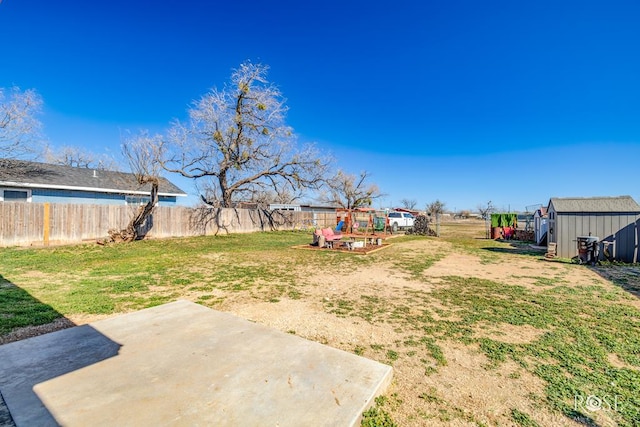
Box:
[109,133,161,242]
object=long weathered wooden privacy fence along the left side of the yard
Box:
[0,202,336,246]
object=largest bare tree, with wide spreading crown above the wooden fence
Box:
[158,62,329,207]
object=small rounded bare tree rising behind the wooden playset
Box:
[320,170,383,209]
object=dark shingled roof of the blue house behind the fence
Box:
[0,159,186,196]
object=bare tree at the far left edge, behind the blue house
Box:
[0,87,42,159]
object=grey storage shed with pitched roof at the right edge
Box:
[547,196,640,262]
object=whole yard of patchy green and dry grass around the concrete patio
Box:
[0,221,640,426]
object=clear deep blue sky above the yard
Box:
[0,0,640,210]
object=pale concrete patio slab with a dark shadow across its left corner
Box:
[0,301,392,426]
